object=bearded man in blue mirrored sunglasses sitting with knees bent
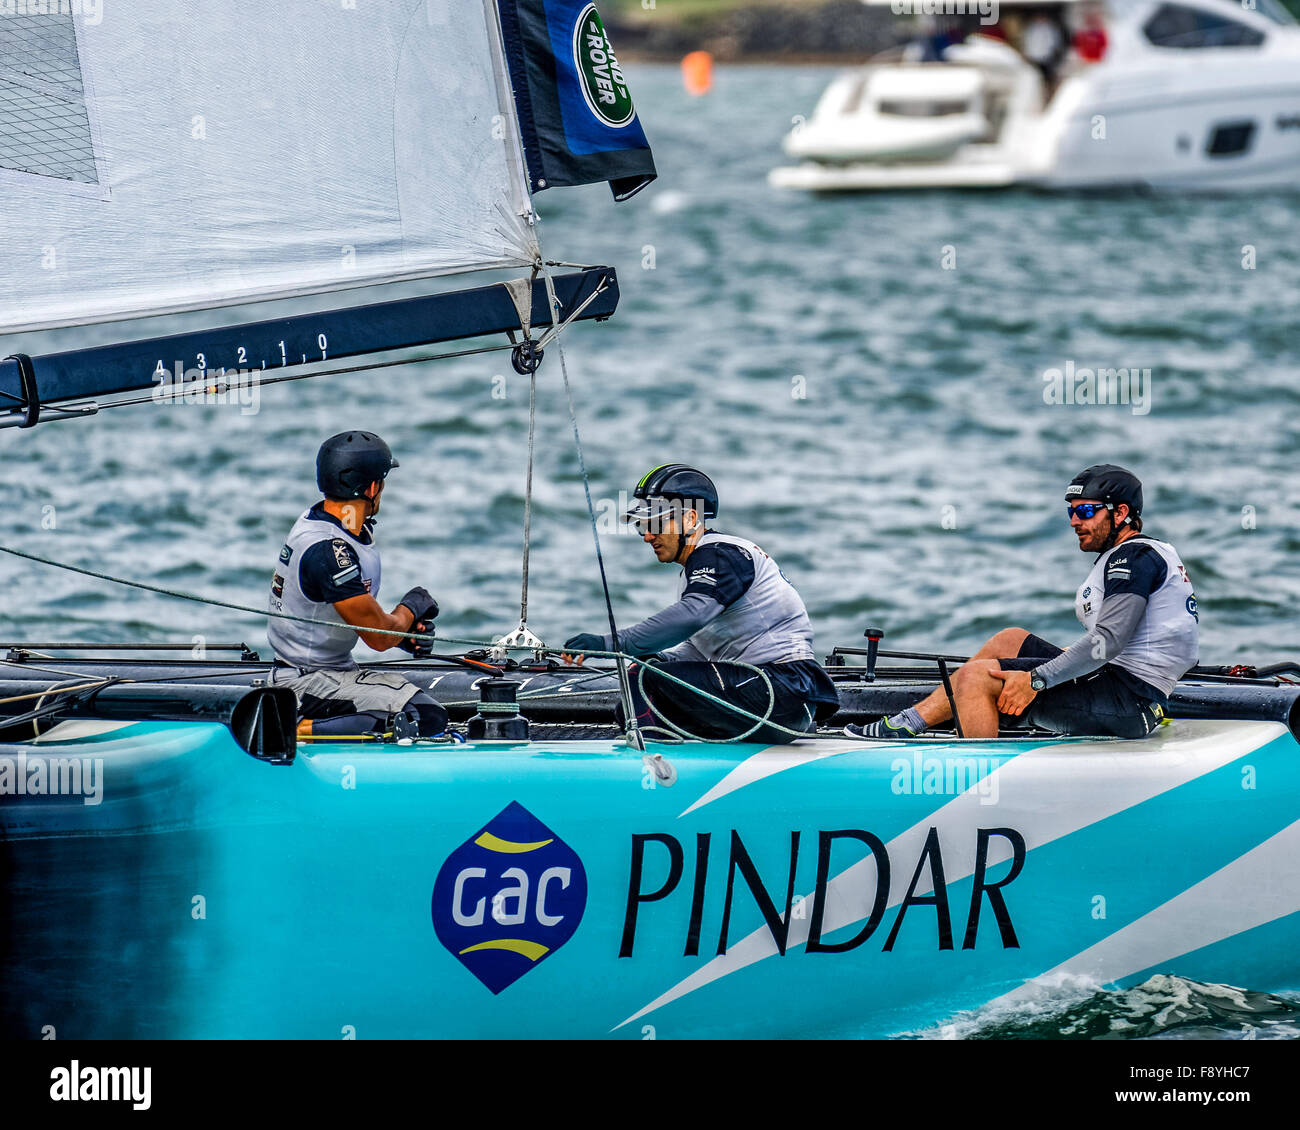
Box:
[845,463,1199,739]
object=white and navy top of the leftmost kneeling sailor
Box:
[267,503,380,671]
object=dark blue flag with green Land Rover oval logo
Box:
[499,0,657,200]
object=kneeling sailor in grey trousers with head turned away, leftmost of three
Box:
[267,432,447,736]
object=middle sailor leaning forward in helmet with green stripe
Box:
[564,463,839,742]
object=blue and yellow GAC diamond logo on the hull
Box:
[433,801,586,993]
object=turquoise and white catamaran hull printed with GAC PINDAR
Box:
[0,720,1300,1039]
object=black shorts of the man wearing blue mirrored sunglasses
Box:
[997,636,1167,737]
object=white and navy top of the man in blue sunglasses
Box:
[1037,533,1200,697]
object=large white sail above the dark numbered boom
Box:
[0,0,537,334]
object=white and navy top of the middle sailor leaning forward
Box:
[605,531,813,664]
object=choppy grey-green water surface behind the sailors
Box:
[0,59,1300,1035]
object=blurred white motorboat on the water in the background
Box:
[770,0,1300,191]
